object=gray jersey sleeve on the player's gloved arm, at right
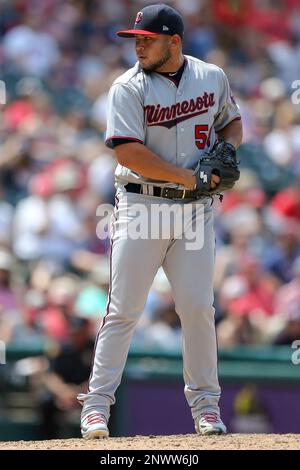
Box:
[214,69,241,132]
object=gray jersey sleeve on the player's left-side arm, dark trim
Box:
[105,83,145,148]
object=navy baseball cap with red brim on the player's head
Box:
[117,4,184,38]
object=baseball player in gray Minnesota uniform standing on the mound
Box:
[78,4,242,439]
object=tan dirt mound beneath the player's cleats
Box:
[0,434,300,451]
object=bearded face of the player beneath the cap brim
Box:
[135,34,172,72]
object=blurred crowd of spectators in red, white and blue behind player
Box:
[0,0,300,436]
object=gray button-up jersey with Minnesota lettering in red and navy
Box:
[106,56,240,191]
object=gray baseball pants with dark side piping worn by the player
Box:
[78,191,220,419]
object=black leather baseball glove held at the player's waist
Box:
[194,140,240,196]
